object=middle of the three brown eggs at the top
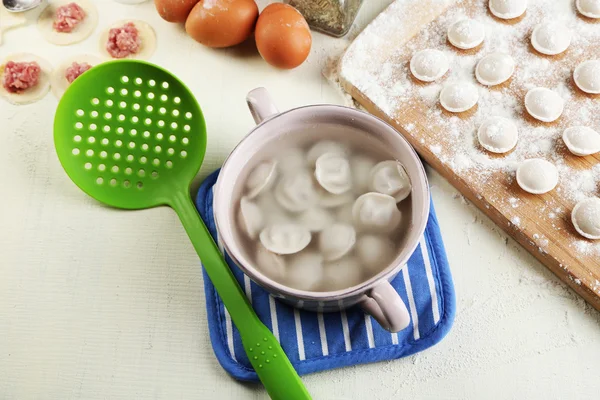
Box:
[185,0,258,47]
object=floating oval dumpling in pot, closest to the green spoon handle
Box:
[259,223,311,254]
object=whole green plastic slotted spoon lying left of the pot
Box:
[54,60,311,400]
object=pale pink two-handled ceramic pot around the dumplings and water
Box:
[214,88,429,332]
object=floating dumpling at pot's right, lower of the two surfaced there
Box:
[352,193,402,233]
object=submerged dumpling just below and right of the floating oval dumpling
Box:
[285,251,323,291]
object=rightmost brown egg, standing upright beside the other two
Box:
[254,3,312,69]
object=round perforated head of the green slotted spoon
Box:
[54,60,206,209]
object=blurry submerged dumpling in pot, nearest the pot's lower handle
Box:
[356,235,397,276]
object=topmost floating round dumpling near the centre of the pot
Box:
[315,153,352,194]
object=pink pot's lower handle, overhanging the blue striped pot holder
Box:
[360,281,410,332]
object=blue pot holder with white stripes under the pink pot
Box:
[196,171,456,381]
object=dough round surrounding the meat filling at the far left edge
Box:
[0,53,52,104]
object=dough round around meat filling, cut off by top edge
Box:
[38,0,98,46]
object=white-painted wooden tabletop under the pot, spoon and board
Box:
[0,0,600,400]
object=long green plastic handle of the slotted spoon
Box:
[171,193,311,400]
